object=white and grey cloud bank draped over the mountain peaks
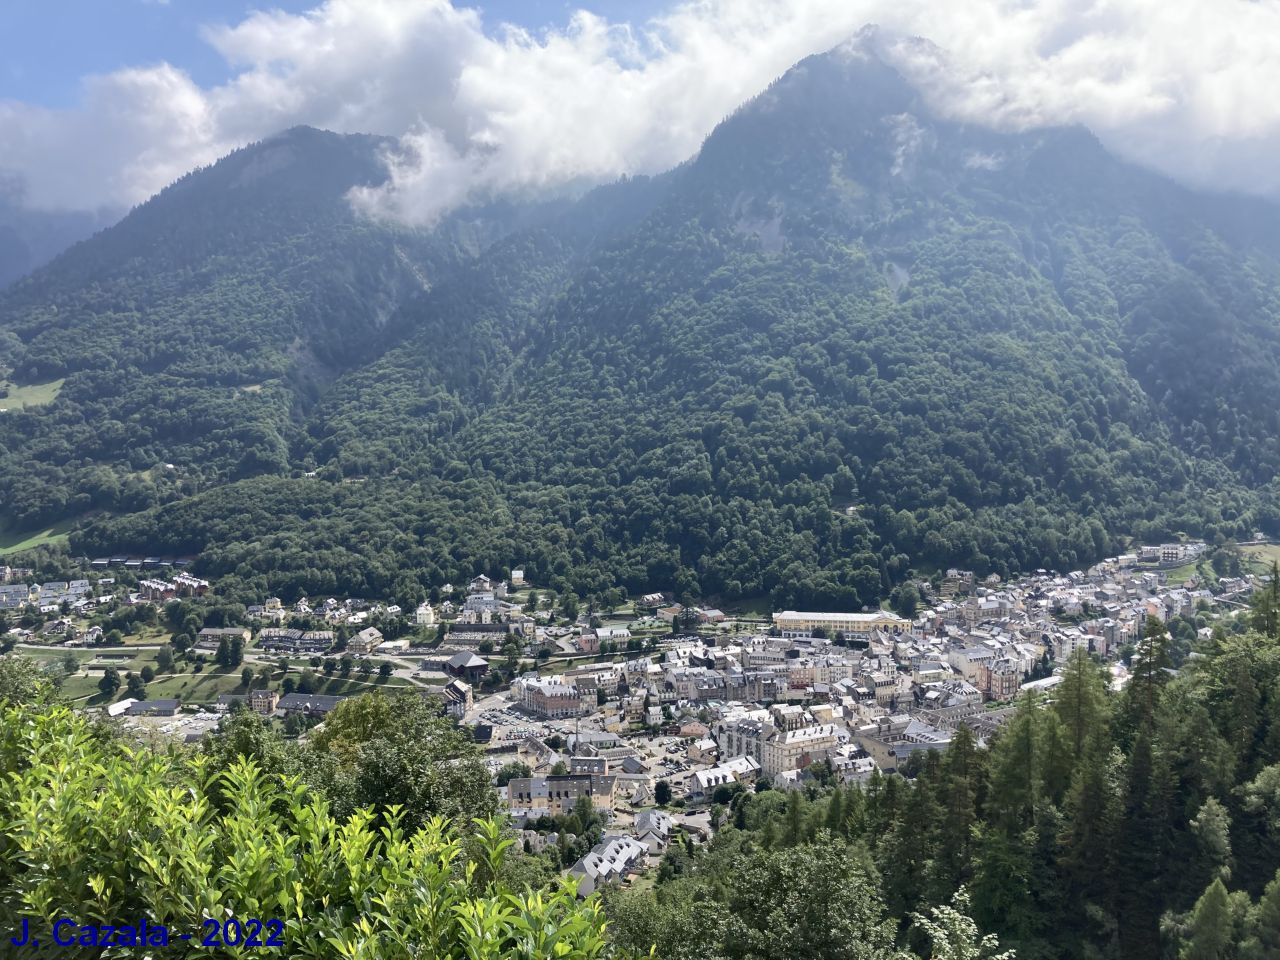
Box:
[0,0,1280,224]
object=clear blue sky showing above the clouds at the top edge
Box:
[0,0,664,108]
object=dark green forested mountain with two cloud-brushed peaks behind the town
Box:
[0,33,1280,607]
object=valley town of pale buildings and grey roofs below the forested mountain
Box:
[0,539,1259,896]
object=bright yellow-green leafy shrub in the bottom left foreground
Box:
[0,707,612,960]
